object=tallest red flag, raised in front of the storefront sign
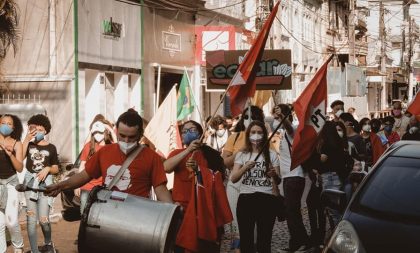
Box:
[229,1,280,117]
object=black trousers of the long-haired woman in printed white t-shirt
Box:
[236,192,277,253]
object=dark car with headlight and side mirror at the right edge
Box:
[322,141,420,253]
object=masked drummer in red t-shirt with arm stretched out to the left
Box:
[46,109,173,203]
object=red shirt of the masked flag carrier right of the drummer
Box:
[168,148,207,210]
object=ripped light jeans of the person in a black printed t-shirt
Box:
[25,191,51,253]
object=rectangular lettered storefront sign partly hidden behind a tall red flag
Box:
[206,50,292,90]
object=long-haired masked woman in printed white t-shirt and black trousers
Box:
[231,121,280,253]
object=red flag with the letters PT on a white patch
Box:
[290,56,333,170]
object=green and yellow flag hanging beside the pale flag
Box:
[177,72,195,121]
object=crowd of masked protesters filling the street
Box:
[0,100,420,253]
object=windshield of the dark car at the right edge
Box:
[358,157,420,219]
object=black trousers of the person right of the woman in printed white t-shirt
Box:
[283,177,309,249]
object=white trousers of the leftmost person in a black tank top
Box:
[0,181,23,252]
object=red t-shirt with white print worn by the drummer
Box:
[86,144,167,198]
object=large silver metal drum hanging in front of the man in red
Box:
[78,186,180,253]
